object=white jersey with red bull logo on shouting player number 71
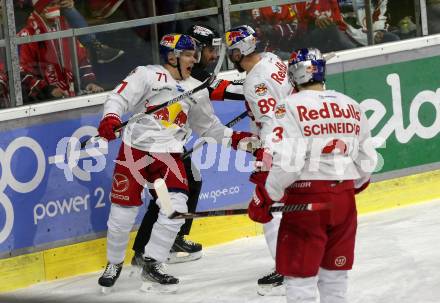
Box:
[104,65,232,153]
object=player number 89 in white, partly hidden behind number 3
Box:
[225,25,293,295]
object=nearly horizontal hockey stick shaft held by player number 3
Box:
[168,203,331,219]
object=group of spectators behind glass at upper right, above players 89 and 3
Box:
[246,0,400,57]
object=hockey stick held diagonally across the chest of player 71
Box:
[80,44,226,149]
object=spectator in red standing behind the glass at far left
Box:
[19,0,103,101]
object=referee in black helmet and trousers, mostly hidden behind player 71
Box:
[131,24,248,267]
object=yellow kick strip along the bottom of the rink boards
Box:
[0,171,440,292]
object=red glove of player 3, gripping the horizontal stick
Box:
[248,185,273,223]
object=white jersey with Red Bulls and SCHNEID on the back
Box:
[266,90,377,201]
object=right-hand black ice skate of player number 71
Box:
[140,258,179,293]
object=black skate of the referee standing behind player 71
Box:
[167,235,202,264]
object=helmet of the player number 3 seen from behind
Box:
[288,48,325,85]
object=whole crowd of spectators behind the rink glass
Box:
[0,0,434,108]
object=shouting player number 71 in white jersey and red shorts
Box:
[94,34,252,291]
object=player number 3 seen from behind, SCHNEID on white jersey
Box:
[248,49,377,303]
